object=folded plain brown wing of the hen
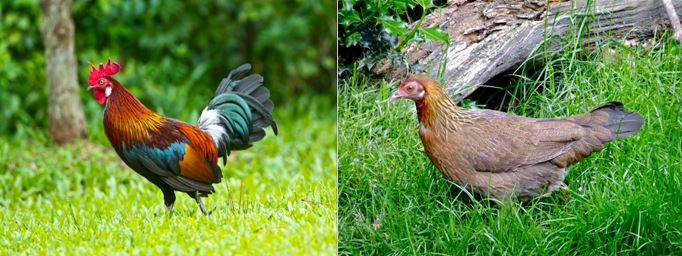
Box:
[453,110,584,172]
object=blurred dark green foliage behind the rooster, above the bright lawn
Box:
[0,0,337,140]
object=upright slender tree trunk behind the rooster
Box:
[40,0,87,144]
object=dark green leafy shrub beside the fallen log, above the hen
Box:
[337,0,449,73]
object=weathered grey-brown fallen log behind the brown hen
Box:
[374,0,682,101]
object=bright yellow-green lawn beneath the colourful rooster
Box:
[0,97,337,255]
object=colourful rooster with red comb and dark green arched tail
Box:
[88,60,277,215]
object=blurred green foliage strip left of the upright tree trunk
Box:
[0,1,48,138]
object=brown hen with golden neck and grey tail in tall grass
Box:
[390,75,643,201]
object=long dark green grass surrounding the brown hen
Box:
[339,38,682,255]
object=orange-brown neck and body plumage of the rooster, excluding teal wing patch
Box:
[104,79,222,194]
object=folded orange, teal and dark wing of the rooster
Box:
[120,119,222,192]
